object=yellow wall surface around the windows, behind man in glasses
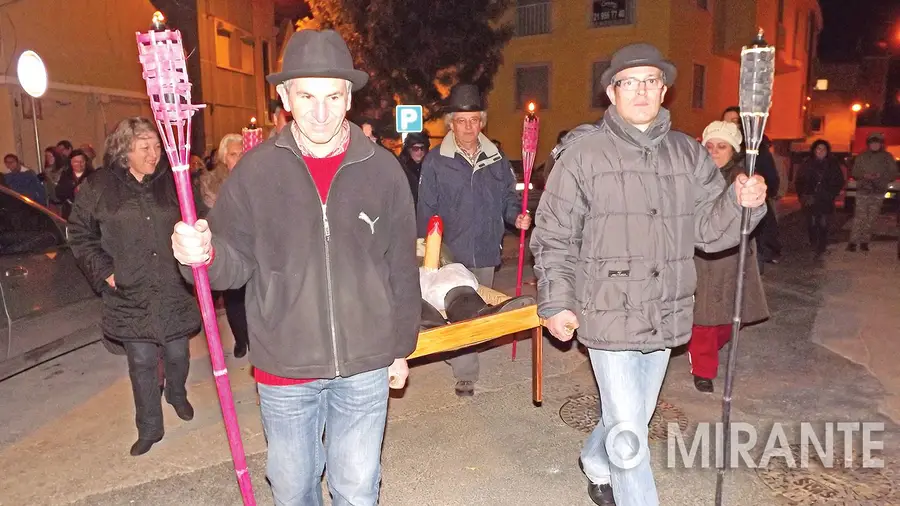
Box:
[486,0,818,163]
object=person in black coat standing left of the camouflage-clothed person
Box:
[794,139,845,257]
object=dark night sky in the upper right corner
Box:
[819,0,900,61]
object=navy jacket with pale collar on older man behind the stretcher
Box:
[416,133,522,269]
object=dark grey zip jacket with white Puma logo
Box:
[182,124,422,379]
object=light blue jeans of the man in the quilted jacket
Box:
[581,350,672,506]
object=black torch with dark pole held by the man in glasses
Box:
[716,30,775,506]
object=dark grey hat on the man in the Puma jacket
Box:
[266,30,369,90]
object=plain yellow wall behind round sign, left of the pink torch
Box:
[0,0,155,167]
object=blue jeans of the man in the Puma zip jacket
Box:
[259,368,388,506]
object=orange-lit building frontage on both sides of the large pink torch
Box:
[0,0,277,172]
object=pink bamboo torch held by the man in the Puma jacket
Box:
[137,12,256,506]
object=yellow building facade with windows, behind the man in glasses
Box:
[488,0,822,160]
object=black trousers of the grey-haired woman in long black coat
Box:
[124,336,191,440]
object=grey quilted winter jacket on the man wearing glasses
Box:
[531,108,765,352]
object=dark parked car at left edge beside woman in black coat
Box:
[0,187,102,380]
